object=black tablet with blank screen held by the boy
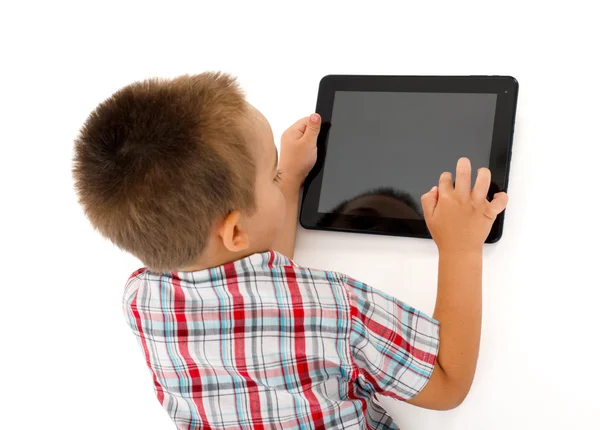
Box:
[300,75,518,243]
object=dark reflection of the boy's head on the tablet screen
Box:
[319,187,423,230]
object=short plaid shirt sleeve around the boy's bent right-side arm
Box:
[345,278,439,401]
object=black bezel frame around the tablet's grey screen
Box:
[300,75,519,243]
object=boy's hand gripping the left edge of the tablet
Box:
[279,113,321,187]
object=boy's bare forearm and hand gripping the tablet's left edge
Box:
[273,114,321,259]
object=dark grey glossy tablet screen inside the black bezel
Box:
[318,91,497,219]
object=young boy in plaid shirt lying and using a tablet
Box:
[74,73,507,429]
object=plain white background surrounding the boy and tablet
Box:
[0,1,600,430]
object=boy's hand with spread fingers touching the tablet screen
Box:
[421,158,508,252]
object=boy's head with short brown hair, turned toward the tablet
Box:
[73,73,285,271]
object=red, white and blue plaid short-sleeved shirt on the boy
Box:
[123,251,439,429]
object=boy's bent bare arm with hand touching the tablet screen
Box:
[408,158,508,410]
